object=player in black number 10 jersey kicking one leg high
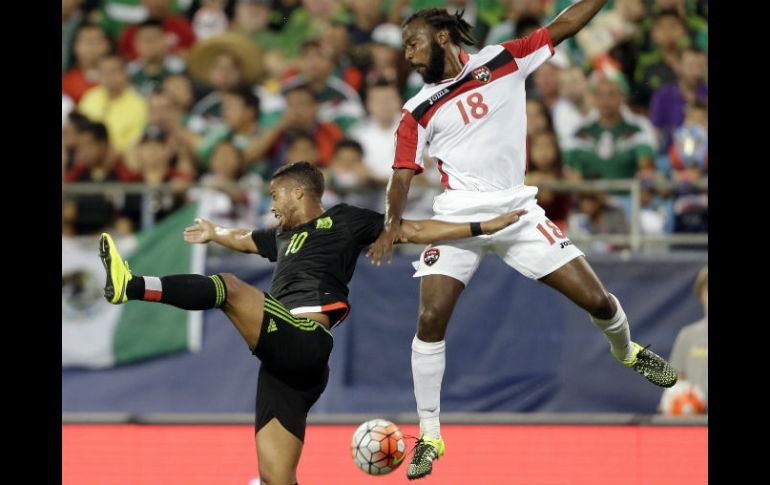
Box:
[99,162,526,485]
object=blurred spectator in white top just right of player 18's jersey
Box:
[551,66,594,146]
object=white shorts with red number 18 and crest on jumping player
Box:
[412,185,584,286]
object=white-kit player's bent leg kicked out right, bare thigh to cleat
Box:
[540,256,677,387]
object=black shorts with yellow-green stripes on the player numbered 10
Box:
[253,293,334,442]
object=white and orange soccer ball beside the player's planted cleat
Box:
[350,419,406,475]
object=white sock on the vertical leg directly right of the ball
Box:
[412,335,446,438]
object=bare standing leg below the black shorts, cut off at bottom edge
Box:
[256,418,302,485]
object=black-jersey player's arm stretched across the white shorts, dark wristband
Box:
[392,209,527,243]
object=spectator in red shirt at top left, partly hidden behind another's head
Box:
[120,0,195,60]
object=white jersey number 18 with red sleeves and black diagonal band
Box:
[393,27,554,192]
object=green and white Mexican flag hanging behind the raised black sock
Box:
[61,203,205,369]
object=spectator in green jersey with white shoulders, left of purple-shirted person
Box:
[565,73,655,179]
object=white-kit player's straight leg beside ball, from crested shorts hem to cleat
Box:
[406,244,483,480]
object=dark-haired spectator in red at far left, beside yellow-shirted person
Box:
[61,23,110,103]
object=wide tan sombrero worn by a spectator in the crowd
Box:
[186,32,265,84]
